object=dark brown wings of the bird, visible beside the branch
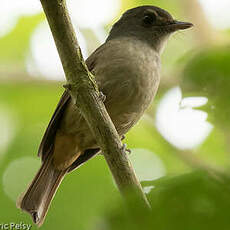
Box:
[38,45,103,164]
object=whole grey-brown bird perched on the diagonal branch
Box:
[17,6,192,226]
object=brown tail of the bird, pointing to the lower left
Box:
[17,154,67,226]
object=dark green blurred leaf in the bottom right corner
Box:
[104,172,230,230]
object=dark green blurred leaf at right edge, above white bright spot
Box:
[181,46,230,129]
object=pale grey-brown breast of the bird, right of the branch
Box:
[94,39,160,134]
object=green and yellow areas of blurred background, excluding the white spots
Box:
[0,0,230,230]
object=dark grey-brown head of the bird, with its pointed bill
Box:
[107,6,193,52]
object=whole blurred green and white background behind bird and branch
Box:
[0,0,230,230]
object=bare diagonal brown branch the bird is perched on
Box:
[41,0,149,206]
